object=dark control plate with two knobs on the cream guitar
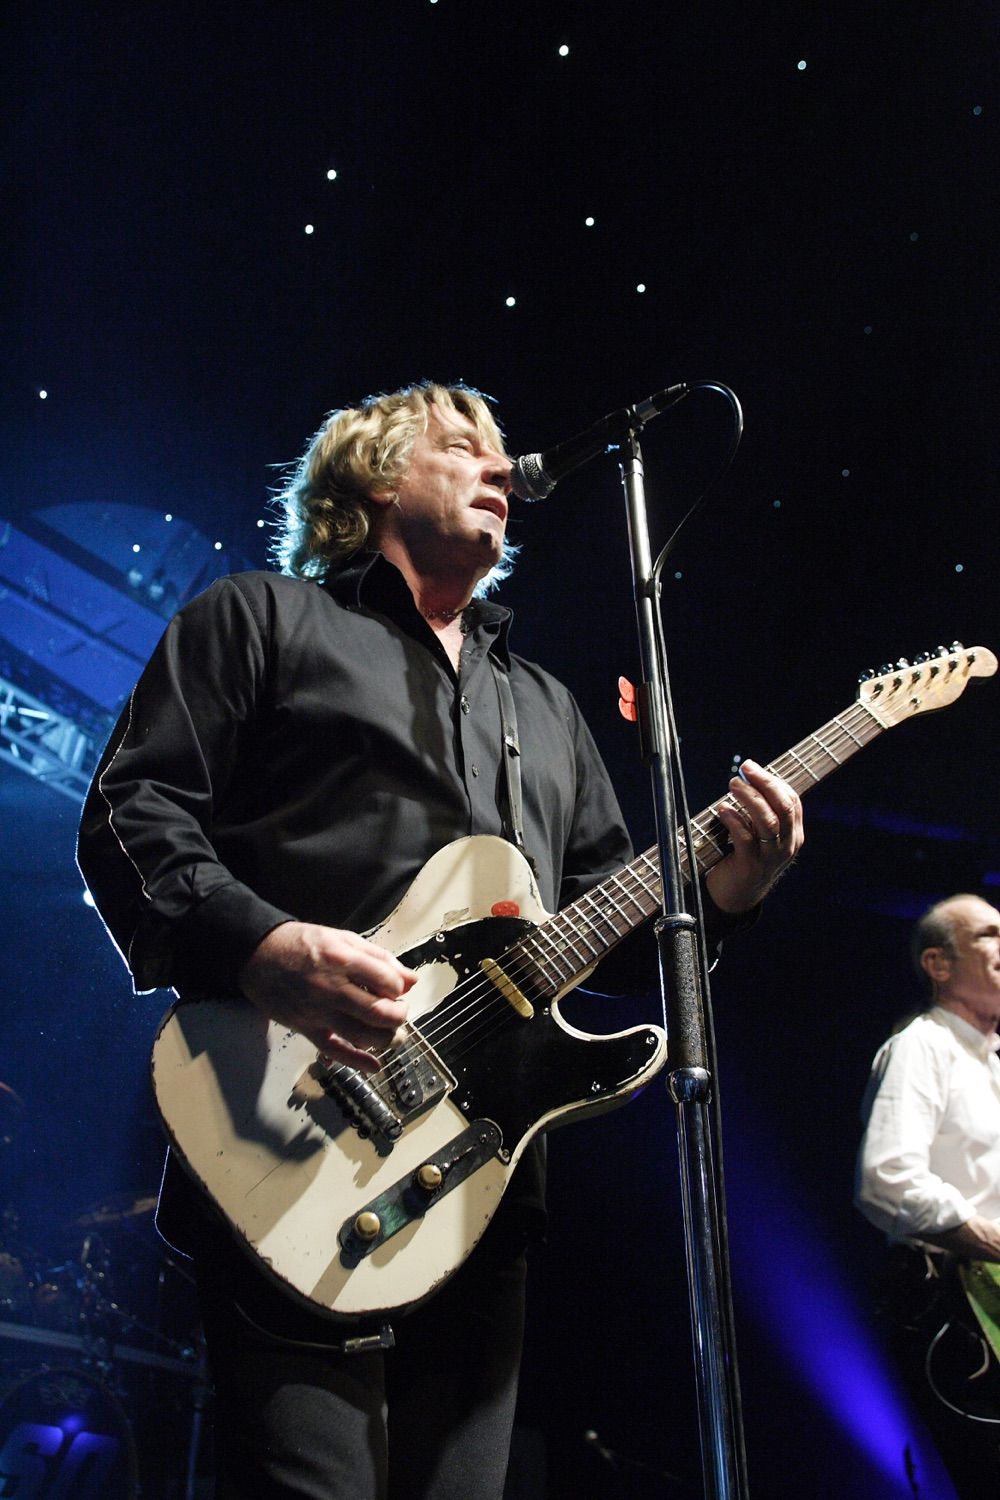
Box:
[337,1121,504,1266]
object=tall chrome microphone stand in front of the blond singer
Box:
[619,408,750,1500]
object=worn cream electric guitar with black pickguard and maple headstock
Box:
[153,645,997,1316]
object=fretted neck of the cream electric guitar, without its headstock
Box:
[519,702,886,993]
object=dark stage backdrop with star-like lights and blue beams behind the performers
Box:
[7,0,1000,1500]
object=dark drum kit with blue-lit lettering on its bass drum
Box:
[0,1083,208,1500]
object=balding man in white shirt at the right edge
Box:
[855,894,1000,1500]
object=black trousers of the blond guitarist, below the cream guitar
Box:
[196,1224,526,1500]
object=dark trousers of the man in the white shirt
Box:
[877,1245,1000,1500]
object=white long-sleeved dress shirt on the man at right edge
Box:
[855,1005,1000,1239]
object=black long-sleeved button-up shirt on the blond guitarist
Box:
[79,552,641,993]
